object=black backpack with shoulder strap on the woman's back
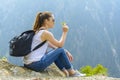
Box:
[9,30,46,57]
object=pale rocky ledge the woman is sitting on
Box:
[0,59,120,80]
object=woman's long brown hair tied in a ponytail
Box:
[33,11,52,31]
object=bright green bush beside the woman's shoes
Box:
[80,64,108,76]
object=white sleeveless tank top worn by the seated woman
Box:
[23,30,48,64]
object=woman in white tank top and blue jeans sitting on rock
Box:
[24,12,85,77]
